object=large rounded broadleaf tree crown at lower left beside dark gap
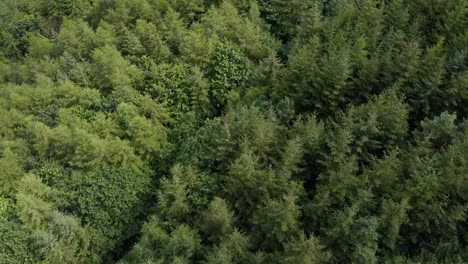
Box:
[74,168,149,254]
